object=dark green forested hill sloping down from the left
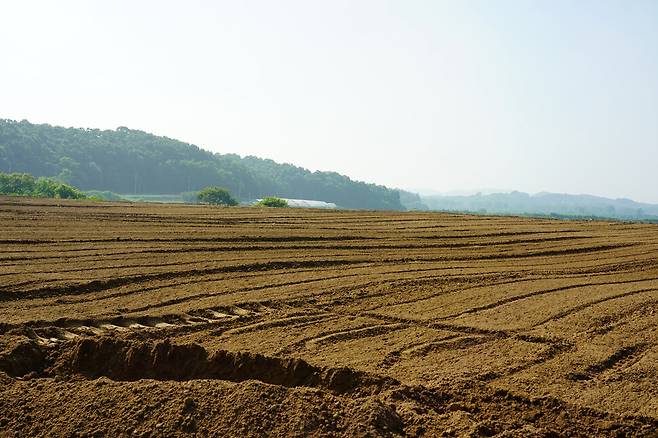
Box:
[0,120,404,210]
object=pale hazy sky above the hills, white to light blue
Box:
[0,0,658,202]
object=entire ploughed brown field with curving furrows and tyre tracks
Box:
[0,198,658,437]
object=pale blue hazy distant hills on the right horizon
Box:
[421,192,658,220]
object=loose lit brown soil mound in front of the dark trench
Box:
[0,377,403,437]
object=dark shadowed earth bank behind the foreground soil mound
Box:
[49,337,399,395]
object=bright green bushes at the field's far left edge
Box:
[0,172,87,199]
